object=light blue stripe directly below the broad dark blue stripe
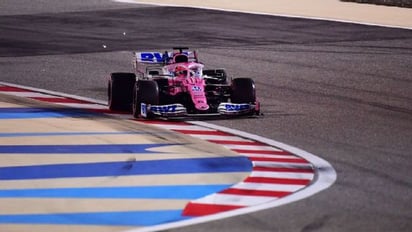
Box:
[0,185,230,200]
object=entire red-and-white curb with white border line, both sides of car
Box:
[0,82,336,231]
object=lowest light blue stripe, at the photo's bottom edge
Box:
[0,210,191,226]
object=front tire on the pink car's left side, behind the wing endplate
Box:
[133,80,159,118]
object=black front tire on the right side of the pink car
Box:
[231,78,256,103]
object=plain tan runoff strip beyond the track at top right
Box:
[112,0,412,30]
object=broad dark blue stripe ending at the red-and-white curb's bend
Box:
[0,156,252,180]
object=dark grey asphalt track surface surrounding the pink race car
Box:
[0,1,412,232]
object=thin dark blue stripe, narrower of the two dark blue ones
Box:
[0,144,177,155]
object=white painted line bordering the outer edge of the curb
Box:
[0,81,337,232]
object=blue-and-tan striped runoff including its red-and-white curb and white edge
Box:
[0,83,336,231]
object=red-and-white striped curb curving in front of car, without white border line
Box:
[140,121,315,216]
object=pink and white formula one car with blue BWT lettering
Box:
[108,47,260,118]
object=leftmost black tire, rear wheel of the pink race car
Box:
[107,73,136,112]
